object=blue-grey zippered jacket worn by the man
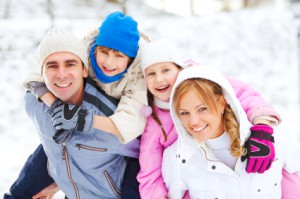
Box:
[25,78,139,199]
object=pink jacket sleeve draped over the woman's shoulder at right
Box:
[228,78,281,124]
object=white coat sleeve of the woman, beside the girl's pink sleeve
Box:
[162,145,186,199]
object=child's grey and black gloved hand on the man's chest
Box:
[51,103,94,132]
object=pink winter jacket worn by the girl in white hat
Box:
[137,79,300,199]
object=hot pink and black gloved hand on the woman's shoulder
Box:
[241,124,275,173]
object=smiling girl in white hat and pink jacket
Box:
[138,40,300,199]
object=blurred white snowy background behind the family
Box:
[0,0,300,198]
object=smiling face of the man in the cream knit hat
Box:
[42,52,88,104]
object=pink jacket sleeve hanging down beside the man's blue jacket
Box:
[137,118,168,199]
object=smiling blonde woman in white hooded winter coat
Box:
[162,66,300,199]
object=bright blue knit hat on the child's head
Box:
[95,11,140,58]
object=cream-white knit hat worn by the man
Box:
[37,28,89,71]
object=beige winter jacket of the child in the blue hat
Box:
[24,30,150,143]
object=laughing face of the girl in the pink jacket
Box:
[145,62,181,101]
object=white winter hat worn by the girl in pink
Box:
[141,39,185,75]
